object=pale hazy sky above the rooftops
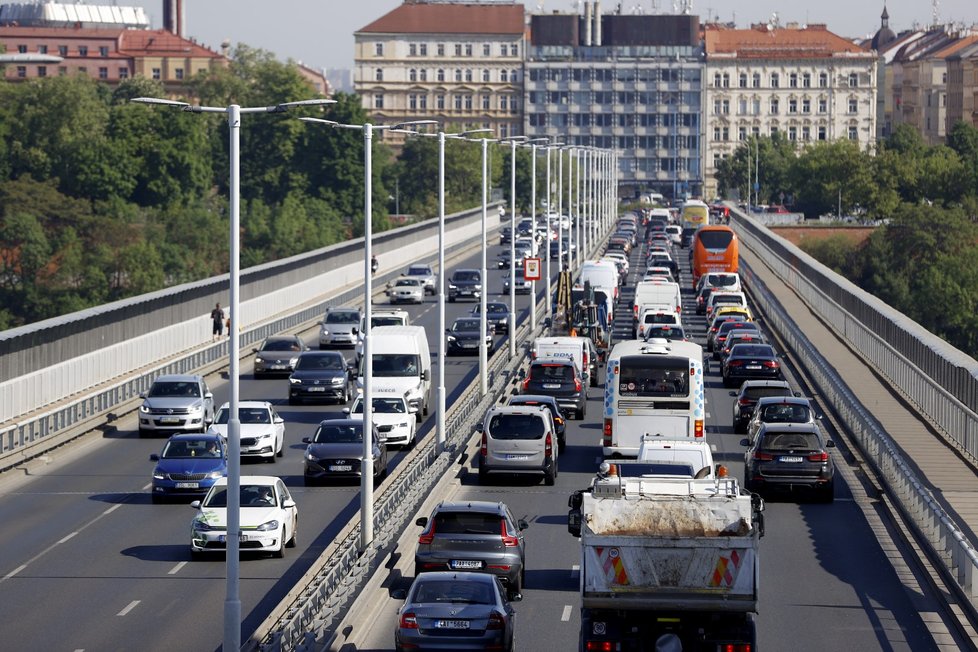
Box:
[122,0,978,69]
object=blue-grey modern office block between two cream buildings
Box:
[524,8,703,197]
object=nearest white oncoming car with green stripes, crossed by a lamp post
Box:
[190,475,299,559]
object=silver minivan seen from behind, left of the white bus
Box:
[476,405,559,486]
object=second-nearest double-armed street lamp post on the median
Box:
[298,118,437,552]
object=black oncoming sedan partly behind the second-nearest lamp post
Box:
[302,419,387,486]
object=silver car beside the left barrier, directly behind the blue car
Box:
[139,374,214,437]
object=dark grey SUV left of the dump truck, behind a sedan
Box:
[414,500,527,599]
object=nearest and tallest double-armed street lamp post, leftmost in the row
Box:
[130,97,336,650]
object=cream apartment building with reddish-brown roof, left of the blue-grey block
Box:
[353,0,525,143]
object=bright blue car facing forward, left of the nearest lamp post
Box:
[149,434,228,503]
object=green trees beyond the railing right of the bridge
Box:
[722,123,978,356]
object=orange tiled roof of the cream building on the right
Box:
[704,25,869,59]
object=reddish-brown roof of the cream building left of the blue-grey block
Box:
[357,2,524,34]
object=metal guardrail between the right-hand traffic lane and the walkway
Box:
[741,216,978,610]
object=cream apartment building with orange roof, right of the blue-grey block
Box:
[704,24,877,197]
